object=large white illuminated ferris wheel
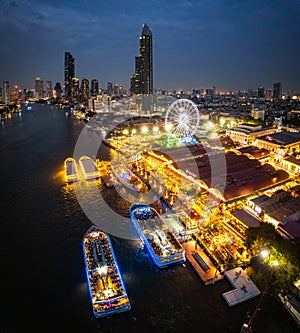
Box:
[165,99,200,139]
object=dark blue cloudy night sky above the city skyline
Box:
[0,0,300,91]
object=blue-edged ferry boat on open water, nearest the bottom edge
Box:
[82,226,131,318]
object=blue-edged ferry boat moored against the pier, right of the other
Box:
[130,202,186,268]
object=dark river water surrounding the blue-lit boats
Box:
[0,105,297,333]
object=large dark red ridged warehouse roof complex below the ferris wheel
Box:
[152,144,289,203]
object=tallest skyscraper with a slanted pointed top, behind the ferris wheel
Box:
[133,24,153,95]
